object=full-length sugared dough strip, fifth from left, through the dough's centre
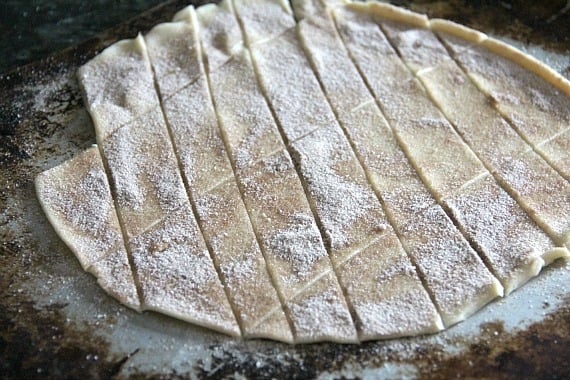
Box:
[236,0,443,339]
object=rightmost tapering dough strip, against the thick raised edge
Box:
[434,33,570,180]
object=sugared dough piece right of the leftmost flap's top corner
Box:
[103,109,188,236]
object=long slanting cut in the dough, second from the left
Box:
[145,35,243,336]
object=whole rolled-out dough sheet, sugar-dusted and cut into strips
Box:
[36,0,570,343]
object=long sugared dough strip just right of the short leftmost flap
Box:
[80,36,240,336]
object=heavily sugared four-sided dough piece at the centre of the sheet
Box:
[291,125,386,255]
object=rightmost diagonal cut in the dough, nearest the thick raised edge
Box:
[438,33,570,180]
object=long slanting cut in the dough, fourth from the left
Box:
[228,0,358,327]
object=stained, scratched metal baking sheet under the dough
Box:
[0,0,570,379]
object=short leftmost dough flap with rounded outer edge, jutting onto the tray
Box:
[35,146,141,310]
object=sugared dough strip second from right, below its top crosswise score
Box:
[392,36,570,244]
